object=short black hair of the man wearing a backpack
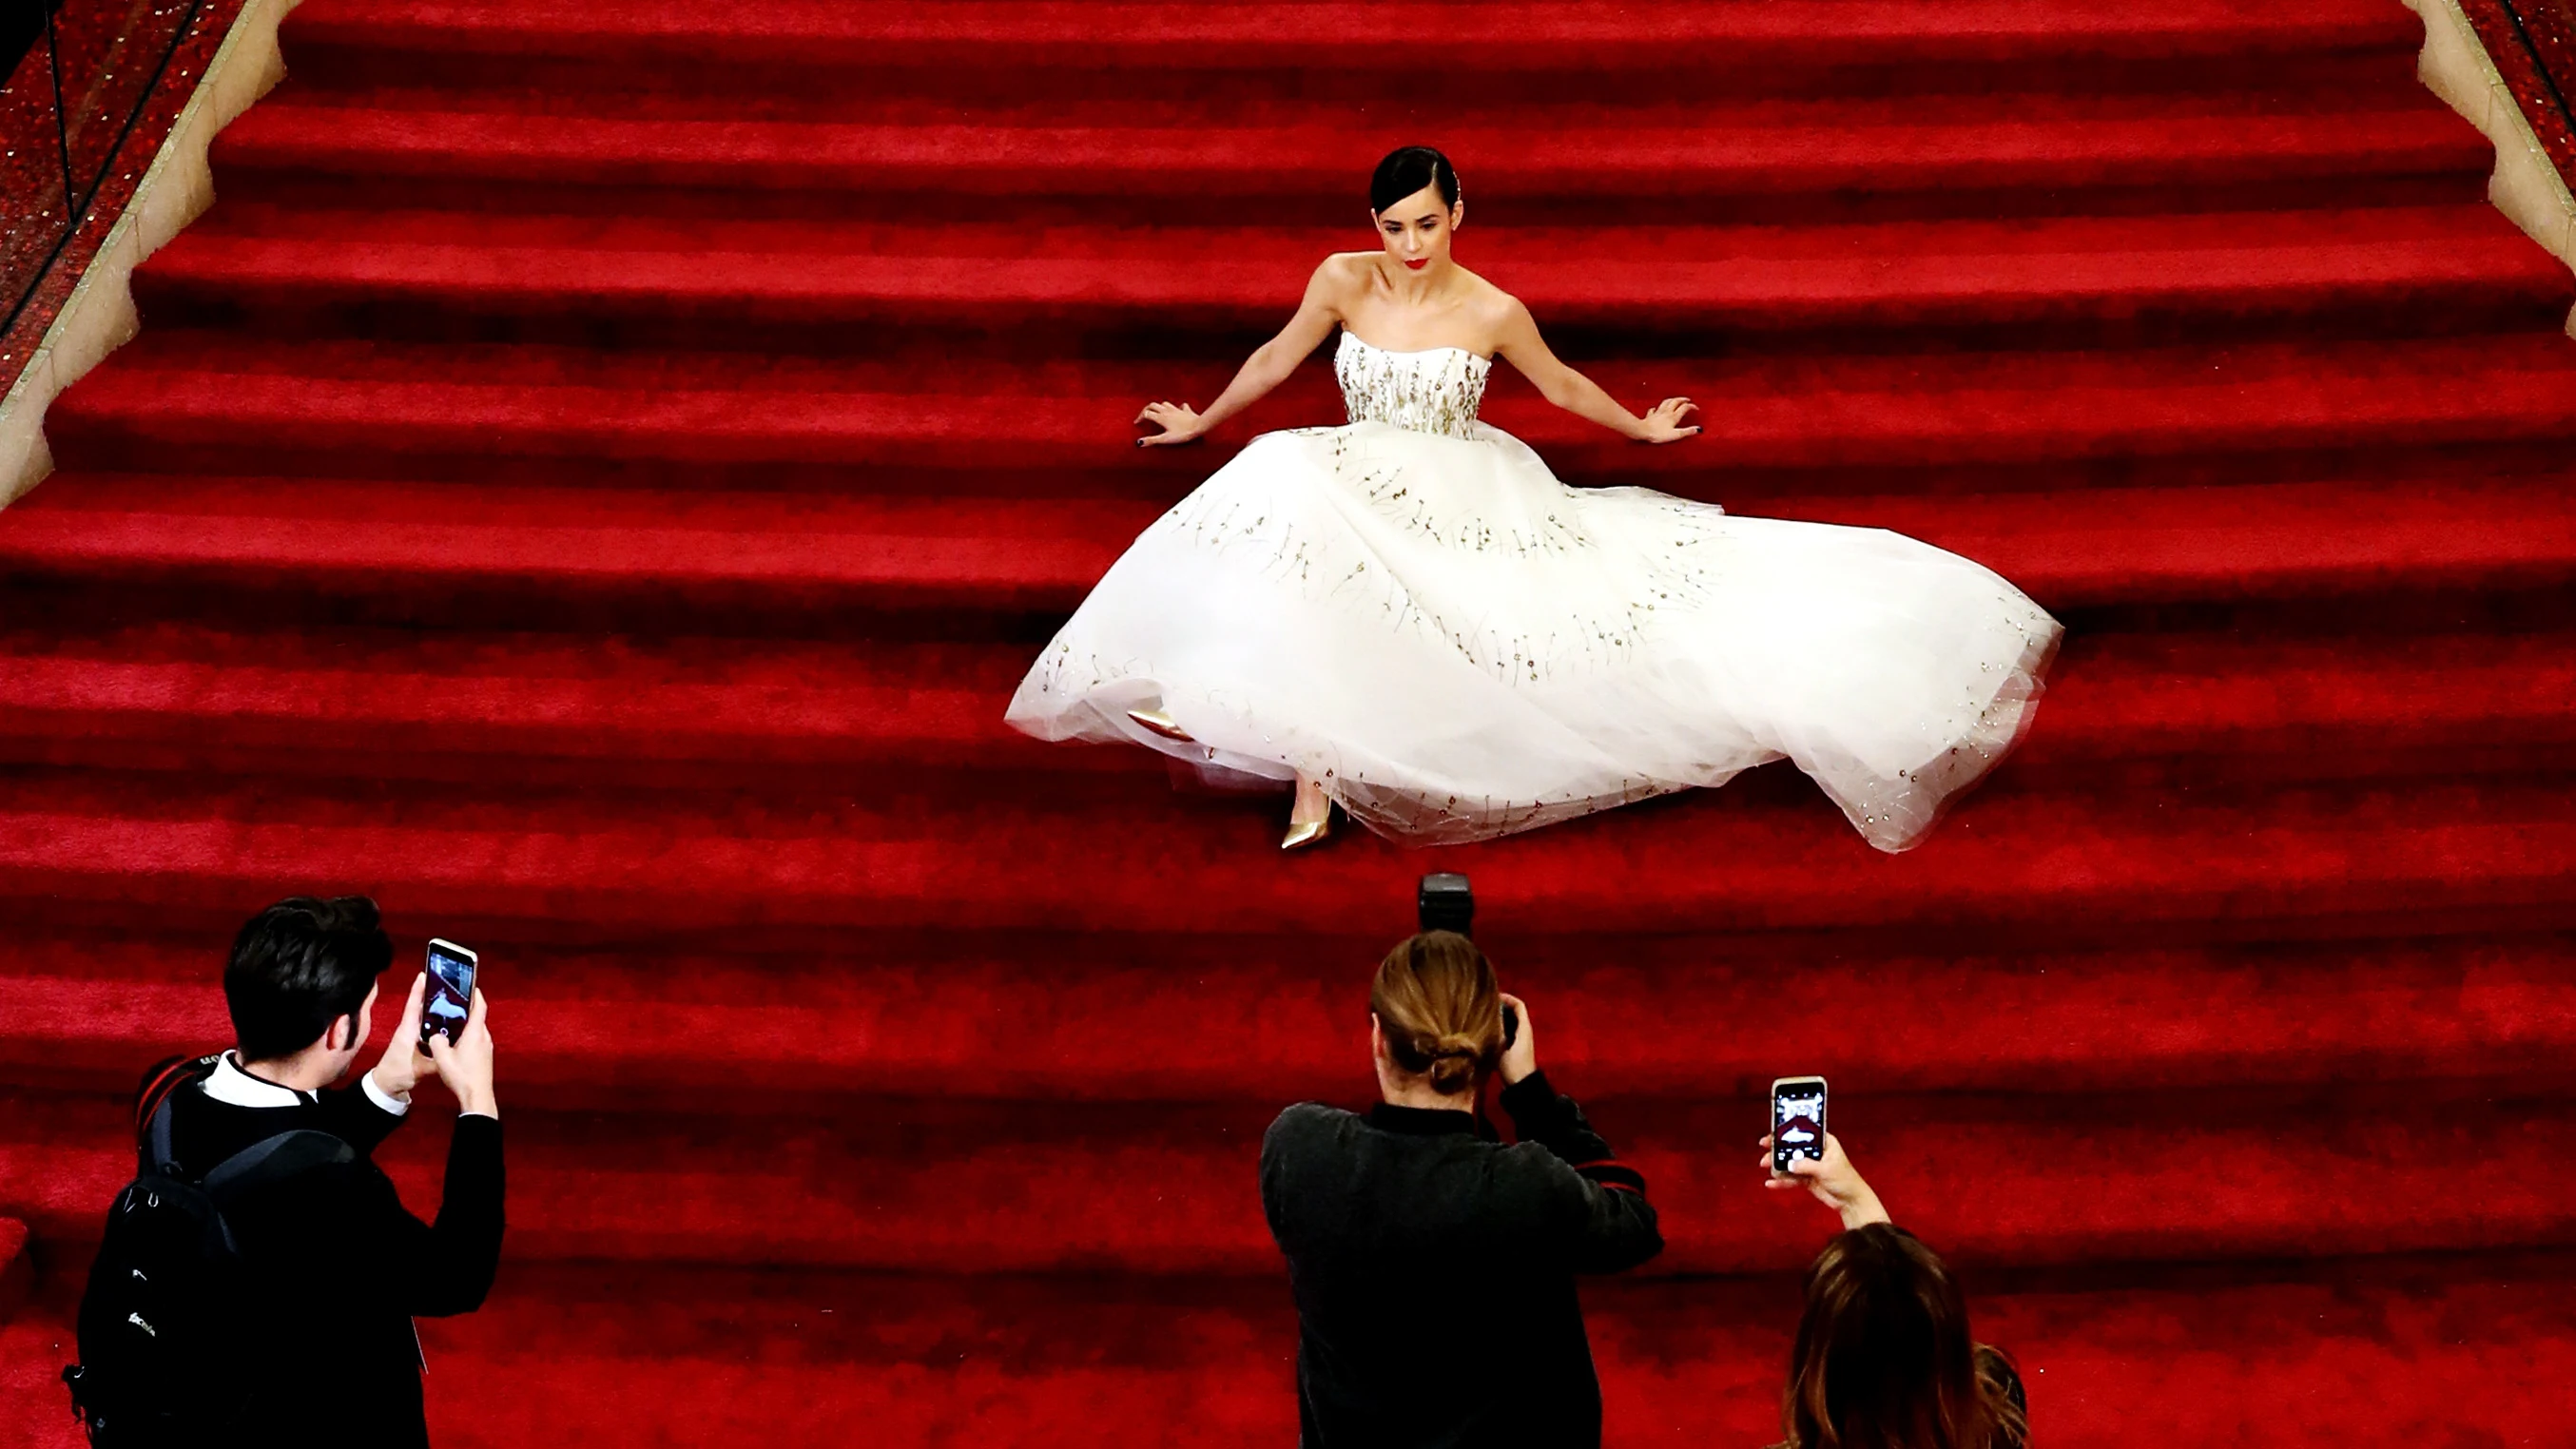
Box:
[224,896,394,1060]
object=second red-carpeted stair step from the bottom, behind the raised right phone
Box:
[0,1071,2576,1277]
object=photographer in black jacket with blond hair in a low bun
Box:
[1262,932,1664,1449]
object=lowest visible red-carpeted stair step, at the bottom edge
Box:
[20,1250,2576,1449]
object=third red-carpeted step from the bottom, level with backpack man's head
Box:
[0,926,2576,1114]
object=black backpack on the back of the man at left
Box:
[62,1055,358,1449]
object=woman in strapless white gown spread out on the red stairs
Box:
[1010,146,2058,849]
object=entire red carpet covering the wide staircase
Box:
[0,0,2576,1449]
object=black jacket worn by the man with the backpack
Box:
[170,1054,502,1446]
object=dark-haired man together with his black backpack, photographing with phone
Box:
[65,896,502,1449]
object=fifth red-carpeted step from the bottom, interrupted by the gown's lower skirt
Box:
[0,623,2576,793]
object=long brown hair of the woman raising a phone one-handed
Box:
[1780,1223,2030,1449]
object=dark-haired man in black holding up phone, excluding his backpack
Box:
[155,896,502,1446]
